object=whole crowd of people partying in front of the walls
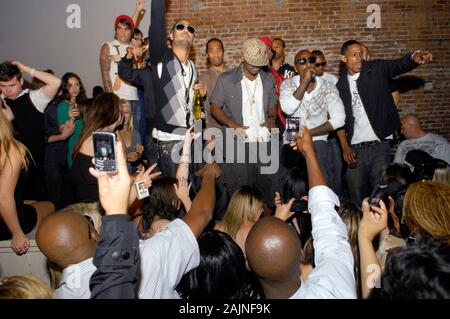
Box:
[0,0,450,299]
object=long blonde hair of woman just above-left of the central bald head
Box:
[214,186,264,254]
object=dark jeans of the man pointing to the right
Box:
[345,142,391,206]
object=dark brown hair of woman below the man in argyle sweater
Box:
[142,176,178,234]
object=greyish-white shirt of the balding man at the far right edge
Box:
[394,133,450,164]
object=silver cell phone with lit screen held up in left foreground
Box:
[92,132,117,174]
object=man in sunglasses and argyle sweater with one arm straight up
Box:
[149,1,206,176]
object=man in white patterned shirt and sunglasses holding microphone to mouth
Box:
[280,50,345,193]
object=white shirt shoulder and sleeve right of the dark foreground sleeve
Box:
[138,219,200,299]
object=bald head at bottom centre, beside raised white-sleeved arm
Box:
[245,217,301,282]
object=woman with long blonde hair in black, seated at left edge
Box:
[0,99,55,255]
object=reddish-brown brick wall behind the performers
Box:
[163,0,450,139]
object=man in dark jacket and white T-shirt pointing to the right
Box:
[336,40,433,205]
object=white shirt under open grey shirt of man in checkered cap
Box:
[241,74,270,142]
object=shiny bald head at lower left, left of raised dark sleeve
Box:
[36,212,98,268]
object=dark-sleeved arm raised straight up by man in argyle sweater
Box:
[148,0,167,66]
